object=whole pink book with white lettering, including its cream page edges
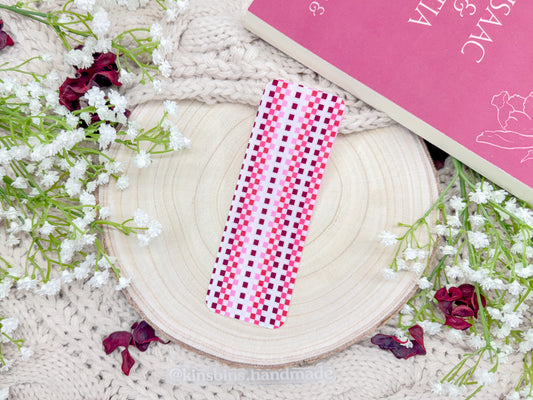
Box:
[245,0,533,204]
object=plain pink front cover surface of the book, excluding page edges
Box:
[250,0,533,187]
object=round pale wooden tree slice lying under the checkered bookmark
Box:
[100,102,438,366]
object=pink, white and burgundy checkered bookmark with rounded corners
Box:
[206,80,344,328]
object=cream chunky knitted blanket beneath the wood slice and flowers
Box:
[0,0,522,400]
